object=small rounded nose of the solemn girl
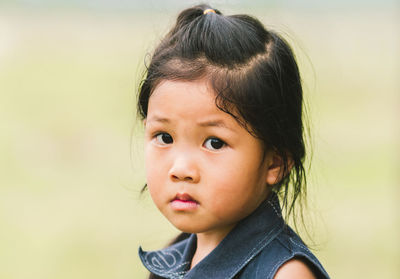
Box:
[168,154,200,183]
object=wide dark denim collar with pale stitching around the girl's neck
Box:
[139,193,284,279]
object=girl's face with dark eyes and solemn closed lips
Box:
[145,80,276,237]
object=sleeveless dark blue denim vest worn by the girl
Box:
[139,194,329,279]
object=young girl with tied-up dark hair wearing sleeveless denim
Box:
[138,5,329,279]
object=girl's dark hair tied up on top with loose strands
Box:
[137,5,305,278]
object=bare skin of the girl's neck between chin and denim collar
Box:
[190,224,236,269]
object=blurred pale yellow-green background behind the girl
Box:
[0,0,400,279]
